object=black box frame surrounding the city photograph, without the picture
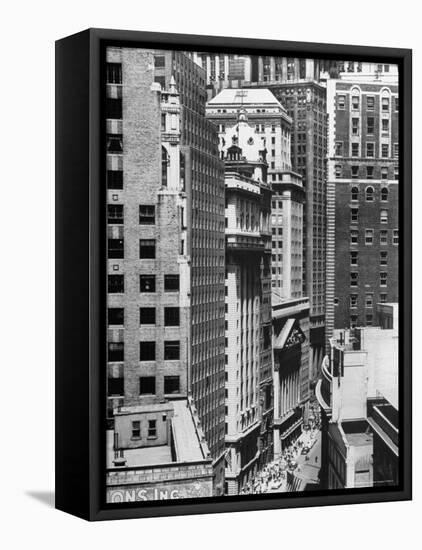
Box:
[56,29,412,521]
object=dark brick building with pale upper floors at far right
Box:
[326,80,399,342]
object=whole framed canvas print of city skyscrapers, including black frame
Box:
[56,29,411,520]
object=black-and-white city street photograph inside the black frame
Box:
[105,45,401,504]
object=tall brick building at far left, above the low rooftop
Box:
[106,48,225,494]
